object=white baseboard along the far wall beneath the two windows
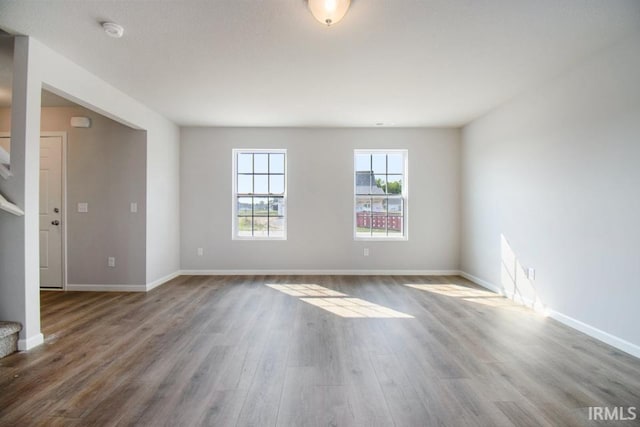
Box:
[180,270,460,276]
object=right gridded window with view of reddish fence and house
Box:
[354,150,407,240]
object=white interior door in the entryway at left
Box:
[40,136,64,288]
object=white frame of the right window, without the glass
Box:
[351,149,409,242]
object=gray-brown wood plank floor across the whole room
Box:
[0,276,640,426]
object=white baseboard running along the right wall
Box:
[460,271,640,358]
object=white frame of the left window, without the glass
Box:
[231,148,289,241]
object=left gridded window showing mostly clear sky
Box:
[233,150,287,240]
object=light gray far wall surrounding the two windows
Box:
[180,128,460,271]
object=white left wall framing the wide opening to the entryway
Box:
[0,37,180,348]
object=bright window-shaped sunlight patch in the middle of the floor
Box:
[267,284,413,319]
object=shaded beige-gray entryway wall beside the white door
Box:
[0,107,147,289]
